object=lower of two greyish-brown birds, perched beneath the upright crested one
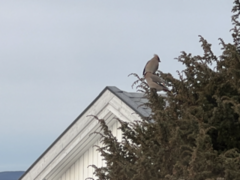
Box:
[144,72,171,92]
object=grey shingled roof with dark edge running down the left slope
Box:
[19,86,151,180]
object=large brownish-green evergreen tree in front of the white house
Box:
[89,0,240,180]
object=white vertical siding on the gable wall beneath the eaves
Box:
[58,121,122,180]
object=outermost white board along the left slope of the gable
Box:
[19,88,114,180]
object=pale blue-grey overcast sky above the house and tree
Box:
[0,0,233,172]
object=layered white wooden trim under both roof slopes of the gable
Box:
[22,89,144,180]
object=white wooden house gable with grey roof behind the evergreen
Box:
[19,87,150,180]
